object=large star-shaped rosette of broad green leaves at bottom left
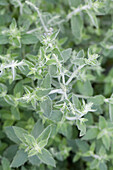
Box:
[5,121,55,167]
